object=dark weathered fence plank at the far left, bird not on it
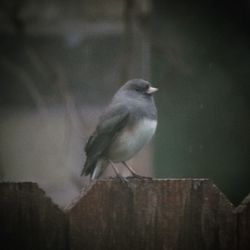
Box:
[0,183,67,250]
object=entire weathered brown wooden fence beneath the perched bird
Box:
[0,179,250,250]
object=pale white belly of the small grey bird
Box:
[108,119,157,162]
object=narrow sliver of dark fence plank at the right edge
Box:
[236,194,250,250]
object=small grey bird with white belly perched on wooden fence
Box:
[81,79,158,179]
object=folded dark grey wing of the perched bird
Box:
[81,107,129,175]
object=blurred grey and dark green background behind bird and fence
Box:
[0,0,250,206]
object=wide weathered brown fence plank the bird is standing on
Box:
[68,179,236,250]
